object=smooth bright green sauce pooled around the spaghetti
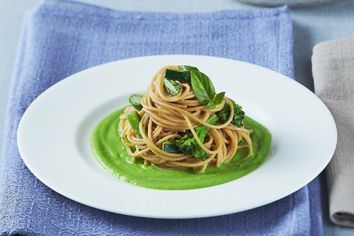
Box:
[91,109,271,190]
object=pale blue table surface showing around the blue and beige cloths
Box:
[0,0,354,236]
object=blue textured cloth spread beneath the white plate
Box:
[0,1,322,235]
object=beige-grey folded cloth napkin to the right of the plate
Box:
[312,38,354,227]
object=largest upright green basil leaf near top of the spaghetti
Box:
[190,70,215,105]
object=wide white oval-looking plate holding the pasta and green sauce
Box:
[17,55,337,218]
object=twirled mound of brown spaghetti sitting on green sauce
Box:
[119,66,253,173]
